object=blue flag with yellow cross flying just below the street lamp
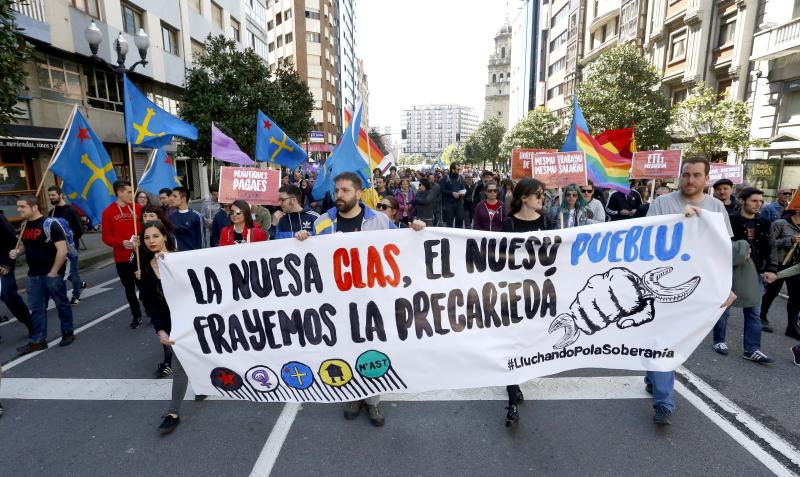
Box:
[123,76,197,149]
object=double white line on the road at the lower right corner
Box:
[675,366,800,475]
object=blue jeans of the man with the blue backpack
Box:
[28,274,73,342]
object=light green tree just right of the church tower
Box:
[500,108,564,161]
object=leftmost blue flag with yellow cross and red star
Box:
[50,111,117,224]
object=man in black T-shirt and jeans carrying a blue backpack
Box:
[8,196,75,355]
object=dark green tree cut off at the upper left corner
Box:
[0,0,28,128]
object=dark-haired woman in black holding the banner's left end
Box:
[136,221,205,435]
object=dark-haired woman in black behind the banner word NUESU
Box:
[503,178,553,427]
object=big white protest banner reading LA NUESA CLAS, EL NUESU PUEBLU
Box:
[160,212,731,402]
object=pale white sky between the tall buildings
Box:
[356,0,515,142]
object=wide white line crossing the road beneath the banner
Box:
[0,376,650,402]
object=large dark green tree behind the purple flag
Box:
[179,35,314,161]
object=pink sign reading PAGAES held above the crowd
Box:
[219,166,281,205]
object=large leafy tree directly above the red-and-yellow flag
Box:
[577,45,670,149]
